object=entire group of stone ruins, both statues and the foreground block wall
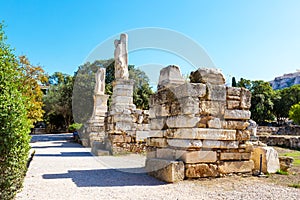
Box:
[82,34,279,182]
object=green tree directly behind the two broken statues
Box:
[73,59,153,123]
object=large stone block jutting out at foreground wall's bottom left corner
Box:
[145,158,184,183]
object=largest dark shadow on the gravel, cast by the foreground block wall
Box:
[43,168,166,187]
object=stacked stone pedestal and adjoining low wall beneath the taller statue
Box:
[107,79,149,154]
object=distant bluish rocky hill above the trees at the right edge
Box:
[270,70,300,90]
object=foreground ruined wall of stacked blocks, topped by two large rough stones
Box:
[146,66,253,182]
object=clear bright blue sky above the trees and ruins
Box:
[0,0,300,85]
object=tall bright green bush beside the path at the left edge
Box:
[0,23,31,199]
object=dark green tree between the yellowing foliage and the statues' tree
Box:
[43,72,74,131]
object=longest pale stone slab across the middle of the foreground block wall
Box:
[165,128,236,140]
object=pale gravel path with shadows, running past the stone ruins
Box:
[16,134,300,200]
